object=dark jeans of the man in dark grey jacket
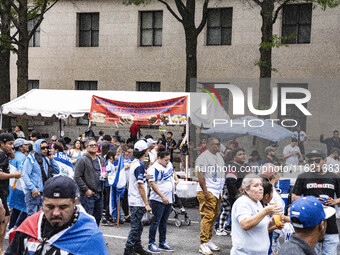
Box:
[80,194,103,226]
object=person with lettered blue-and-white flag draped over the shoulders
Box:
[51,142,74,179]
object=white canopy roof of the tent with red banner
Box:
[0,89,229,128]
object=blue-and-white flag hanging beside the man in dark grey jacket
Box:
[109,152,126,219]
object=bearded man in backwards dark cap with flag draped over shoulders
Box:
[5,176,108,255]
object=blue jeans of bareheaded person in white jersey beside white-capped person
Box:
[149,200,172,244]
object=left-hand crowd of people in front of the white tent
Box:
[0,129,187,254]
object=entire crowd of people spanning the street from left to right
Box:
[0,125,340,255]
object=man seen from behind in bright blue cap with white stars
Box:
[278,196,336,255]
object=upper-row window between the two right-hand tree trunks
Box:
[207,8,233,45]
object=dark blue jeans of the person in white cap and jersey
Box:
[125,206,146,248]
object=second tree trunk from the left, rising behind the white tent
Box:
[17,0,29,134]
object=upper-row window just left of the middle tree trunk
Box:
[140,11,163,46]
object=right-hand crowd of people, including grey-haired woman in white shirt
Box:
[196,127,340,255]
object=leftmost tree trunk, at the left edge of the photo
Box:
[0,0,11,129]
